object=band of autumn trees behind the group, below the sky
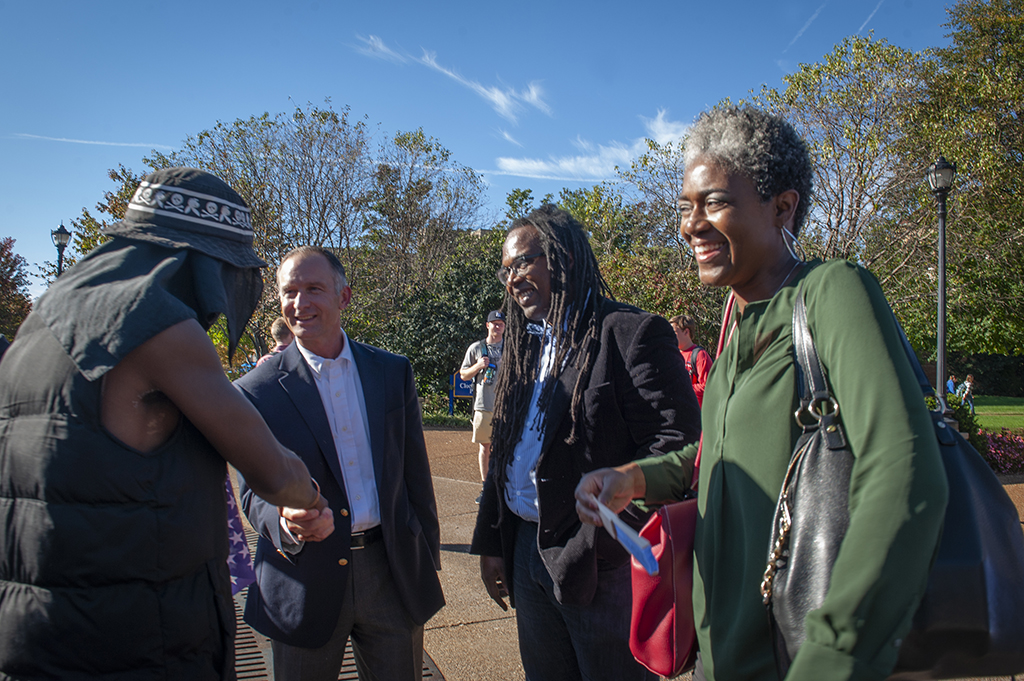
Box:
[73,0,1024,391]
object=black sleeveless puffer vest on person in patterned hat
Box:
[0,312,234,681]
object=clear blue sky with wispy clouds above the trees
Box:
[0,0,951,294]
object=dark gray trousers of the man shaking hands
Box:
[270,542,423,681]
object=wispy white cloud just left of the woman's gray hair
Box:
[488,110,688,182]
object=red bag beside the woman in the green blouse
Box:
[630,499,697,677]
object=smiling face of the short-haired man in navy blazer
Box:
[278,253,352,359]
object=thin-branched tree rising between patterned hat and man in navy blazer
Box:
[145,99,373,353]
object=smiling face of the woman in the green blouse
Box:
[679,156,784,300]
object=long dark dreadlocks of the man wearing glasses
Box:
[490,204,611,488]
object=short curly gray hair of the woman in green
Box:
[683,107,814,235]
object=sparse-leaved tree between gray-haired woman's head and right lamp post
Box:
[755,36,924,265]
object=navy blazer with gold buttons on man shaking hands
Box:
[234,341,444,648]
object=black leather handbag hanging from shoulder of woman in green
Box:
[762,282,1024,680]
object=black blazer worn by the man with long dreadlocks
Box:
[470,300,700,605]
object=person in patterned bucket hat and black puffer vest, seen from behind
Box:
[0,168,333,681]
